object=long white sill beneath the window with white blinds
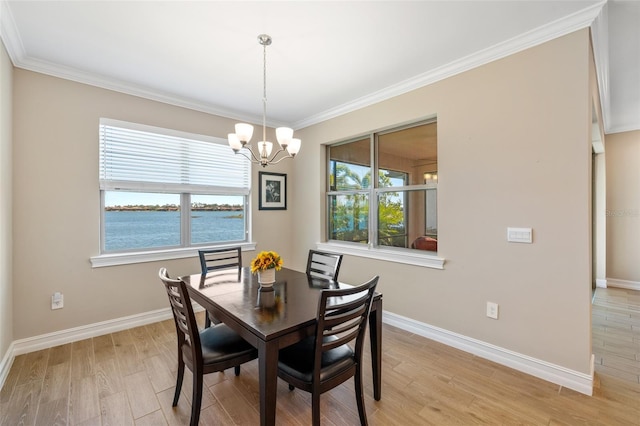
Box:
[90,243,256,268]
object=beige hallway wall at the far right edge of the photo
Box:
[605,131,640,285]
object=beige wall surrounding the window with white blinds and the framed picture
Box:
[13,69,295,340]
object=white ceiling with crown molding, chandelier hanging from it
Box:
[0,0,640,133]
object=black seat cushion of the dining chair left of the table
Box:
[182,324,256,365]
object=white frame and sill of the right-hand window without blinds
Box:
[324,116,445,269]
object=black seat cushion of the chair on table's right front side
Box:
[278,336,355,383]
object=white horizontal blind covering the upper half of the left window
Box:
[100,119,251,195]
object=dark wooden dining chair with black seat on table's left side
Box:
[158,268,258,426]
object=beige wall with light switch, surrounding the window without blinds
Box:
[293,30,591,374]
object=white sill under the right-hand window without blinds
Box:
[317,242,445,269]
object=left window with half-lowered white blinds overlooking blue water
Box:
[100,119,251,254]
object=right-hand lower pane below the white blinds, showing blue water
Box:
[191,195,246,244]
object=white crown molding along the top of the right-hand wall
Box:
[292,0,608,129]
